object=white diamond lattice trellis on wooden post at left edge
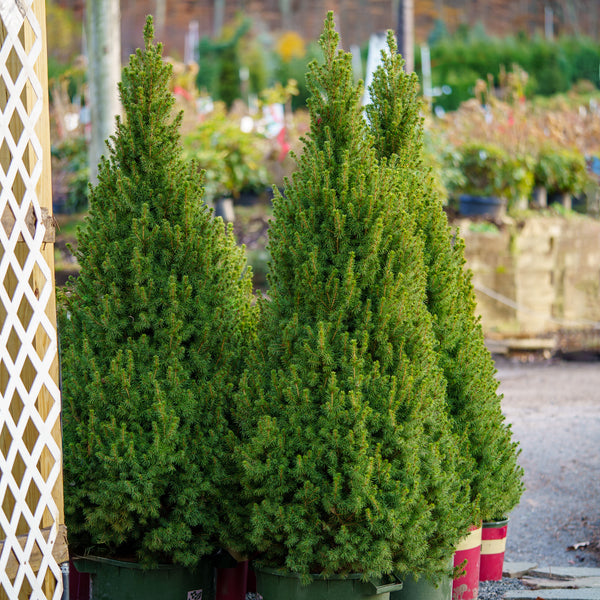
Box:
[0,0,64,600]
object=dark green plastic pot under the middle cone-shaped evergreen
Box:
[255,567,402,600]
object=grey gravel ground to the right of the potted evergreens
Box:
[496,359,600,567]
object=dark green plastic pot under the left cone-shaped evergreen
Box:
[73,556,215,600]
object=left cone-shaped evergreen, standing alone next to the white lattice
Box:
[60,19,253,565]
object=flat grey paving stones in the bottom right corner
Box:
[504,562,600,600]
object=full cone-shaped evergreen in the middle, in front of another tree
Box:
[238,13,472,578]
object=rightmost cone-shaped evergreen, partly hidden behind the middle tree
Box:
[367,32,523,521]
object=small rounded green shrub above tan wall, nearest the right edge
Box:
[534,146,588,210]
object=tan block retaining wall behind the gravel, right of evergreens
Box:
[457,216,600,335]
